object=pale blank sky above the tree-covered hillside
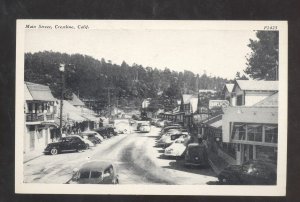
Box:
[25,29,256,79]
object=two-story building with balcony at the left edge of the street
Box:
[24,82,58,153]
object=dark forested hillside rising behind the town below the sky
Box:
[25,51,227,107]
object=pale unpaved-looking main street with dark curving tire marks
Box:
[24,126,217,185]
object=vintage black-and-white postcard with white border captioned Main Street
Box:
[15,19,288,196]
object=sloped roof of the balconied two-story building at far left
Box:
[25,82,56,101]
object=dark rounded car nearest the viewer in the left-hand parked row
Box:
[44,136,87,155]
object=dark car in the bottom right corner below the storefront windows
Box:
[218,160,277,185]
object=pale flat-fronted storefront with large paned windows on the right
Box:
[222,106,278,165]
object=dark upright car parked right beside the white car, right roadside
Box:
[184,143,209,167]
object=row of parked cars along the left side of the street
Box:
[44,127,118,155]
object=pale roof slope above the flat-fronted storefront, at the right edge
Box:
[234,80,278,91]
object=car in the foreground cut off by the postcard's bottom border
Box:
[67,161,119,184]
